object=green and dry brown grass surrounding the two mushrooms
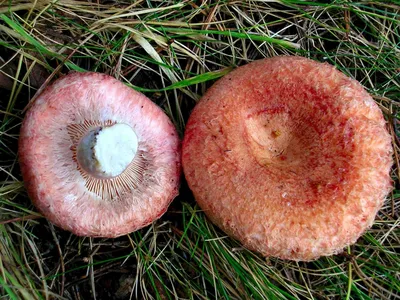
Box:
[0,0,400,299]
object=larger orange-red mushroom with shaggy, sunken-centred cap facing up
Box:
[182,56,392,261]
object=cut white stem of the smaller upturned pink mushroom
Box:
[77,123,138,178]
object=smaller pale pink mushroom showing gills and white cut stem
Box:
[19,72,181,237]
